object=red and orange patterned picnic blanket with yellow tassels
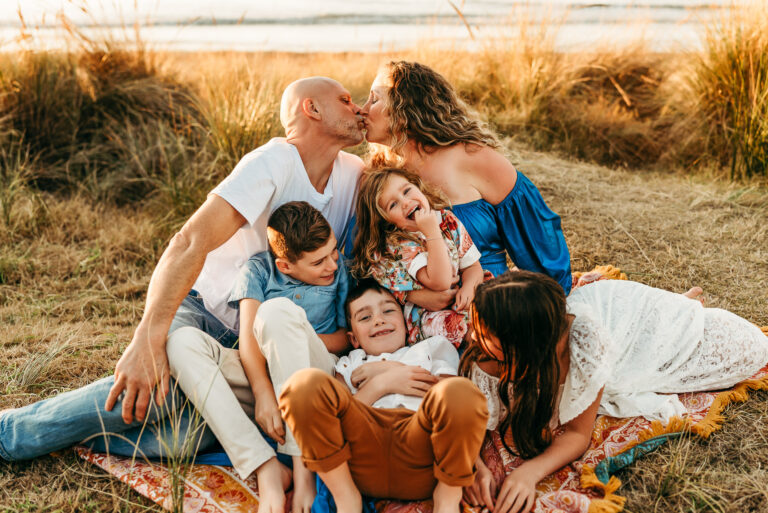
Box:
[77,266,768,513]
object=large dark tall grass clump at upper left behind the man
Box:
[0,20,205,201]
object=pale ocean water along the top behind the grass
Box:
[0,0,732,52]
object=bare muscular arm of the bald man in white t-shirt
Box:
[105,194,246,423]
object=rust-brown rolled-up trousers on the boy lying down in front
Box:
[280,369,488,500]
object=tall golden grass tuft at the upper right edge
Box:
[691,4,768,178]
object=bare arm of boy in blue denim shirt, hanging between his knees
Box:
[239,298,285,443]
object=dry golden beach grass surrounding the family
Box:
[0,3,768,513]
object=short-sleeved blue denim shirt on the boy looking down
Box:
[228,251,349,334]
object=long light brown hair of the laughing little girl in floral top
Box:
[351,167,448,278]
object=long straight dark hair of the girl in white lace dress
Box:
[459,271,568,459]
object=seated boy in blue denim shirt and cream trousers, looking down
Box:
[167,202,348,512]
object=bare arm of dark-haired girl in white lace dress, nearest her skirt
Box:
[494,389,603,513]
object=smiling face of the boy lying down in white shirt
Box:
[347,290,406,356]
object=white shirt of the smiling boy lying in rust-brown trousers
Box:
[336,335,459,411]
